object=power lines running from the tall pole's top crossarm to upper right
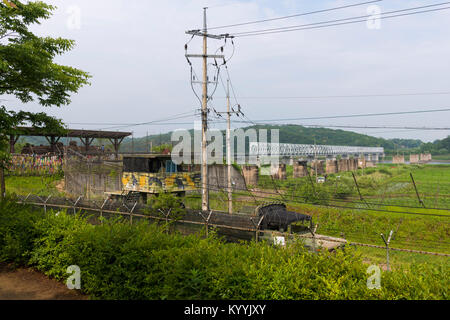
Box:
[233,3,450,37]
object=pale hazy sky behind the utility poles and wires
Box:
[3,0,450,143]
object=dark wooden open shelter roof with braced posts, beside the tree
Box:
[9,127,132,157]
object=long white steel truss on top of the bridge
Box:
[250,142,384,156]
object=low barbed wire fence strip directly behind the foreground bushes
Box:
[14,194,450,257]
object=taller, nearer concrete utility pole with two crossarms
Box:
[186,7,229,211]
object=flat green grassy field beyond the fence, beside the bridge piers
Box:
[6,164,450,266]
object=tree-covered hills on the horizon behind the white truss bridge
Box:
[121,125,423,152]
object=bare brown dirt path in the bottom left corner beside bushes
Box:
[0,264,88,300]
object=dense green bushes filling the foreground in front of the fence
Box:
[0,202,450,300]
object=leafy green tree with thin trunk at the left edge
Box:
[0,0,90,197]
